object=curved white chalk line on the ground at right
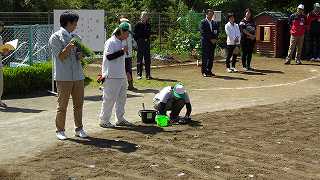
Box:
[191,75,320,91]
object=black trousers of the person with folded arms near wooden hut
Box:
[241,39,255,69]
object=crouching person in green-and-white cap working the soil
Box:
[153,83,192,123]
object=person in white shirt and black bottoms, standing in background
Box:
[225,13,241,73]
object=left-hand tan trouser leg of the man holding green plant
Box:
[56,81,73,132]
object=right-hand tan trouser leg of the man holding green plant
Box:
[71,80,84,131]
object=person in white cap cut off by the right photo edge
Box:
[307,3,320,61]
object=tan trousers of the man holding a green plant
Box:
[56,80,84,131]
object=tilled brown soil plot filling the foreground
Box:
[0,95,320,180]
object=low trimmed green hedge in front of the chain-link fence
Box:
[3,62,52,95]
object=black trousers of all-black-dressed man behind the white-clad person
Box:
[137,39,151,77]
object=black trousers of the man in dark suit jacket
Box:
[201,39,216,74]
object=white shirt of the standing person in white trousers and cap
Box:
[102,35,127,79]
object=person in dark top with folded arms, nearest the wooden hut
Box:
[239,9,256,71]
